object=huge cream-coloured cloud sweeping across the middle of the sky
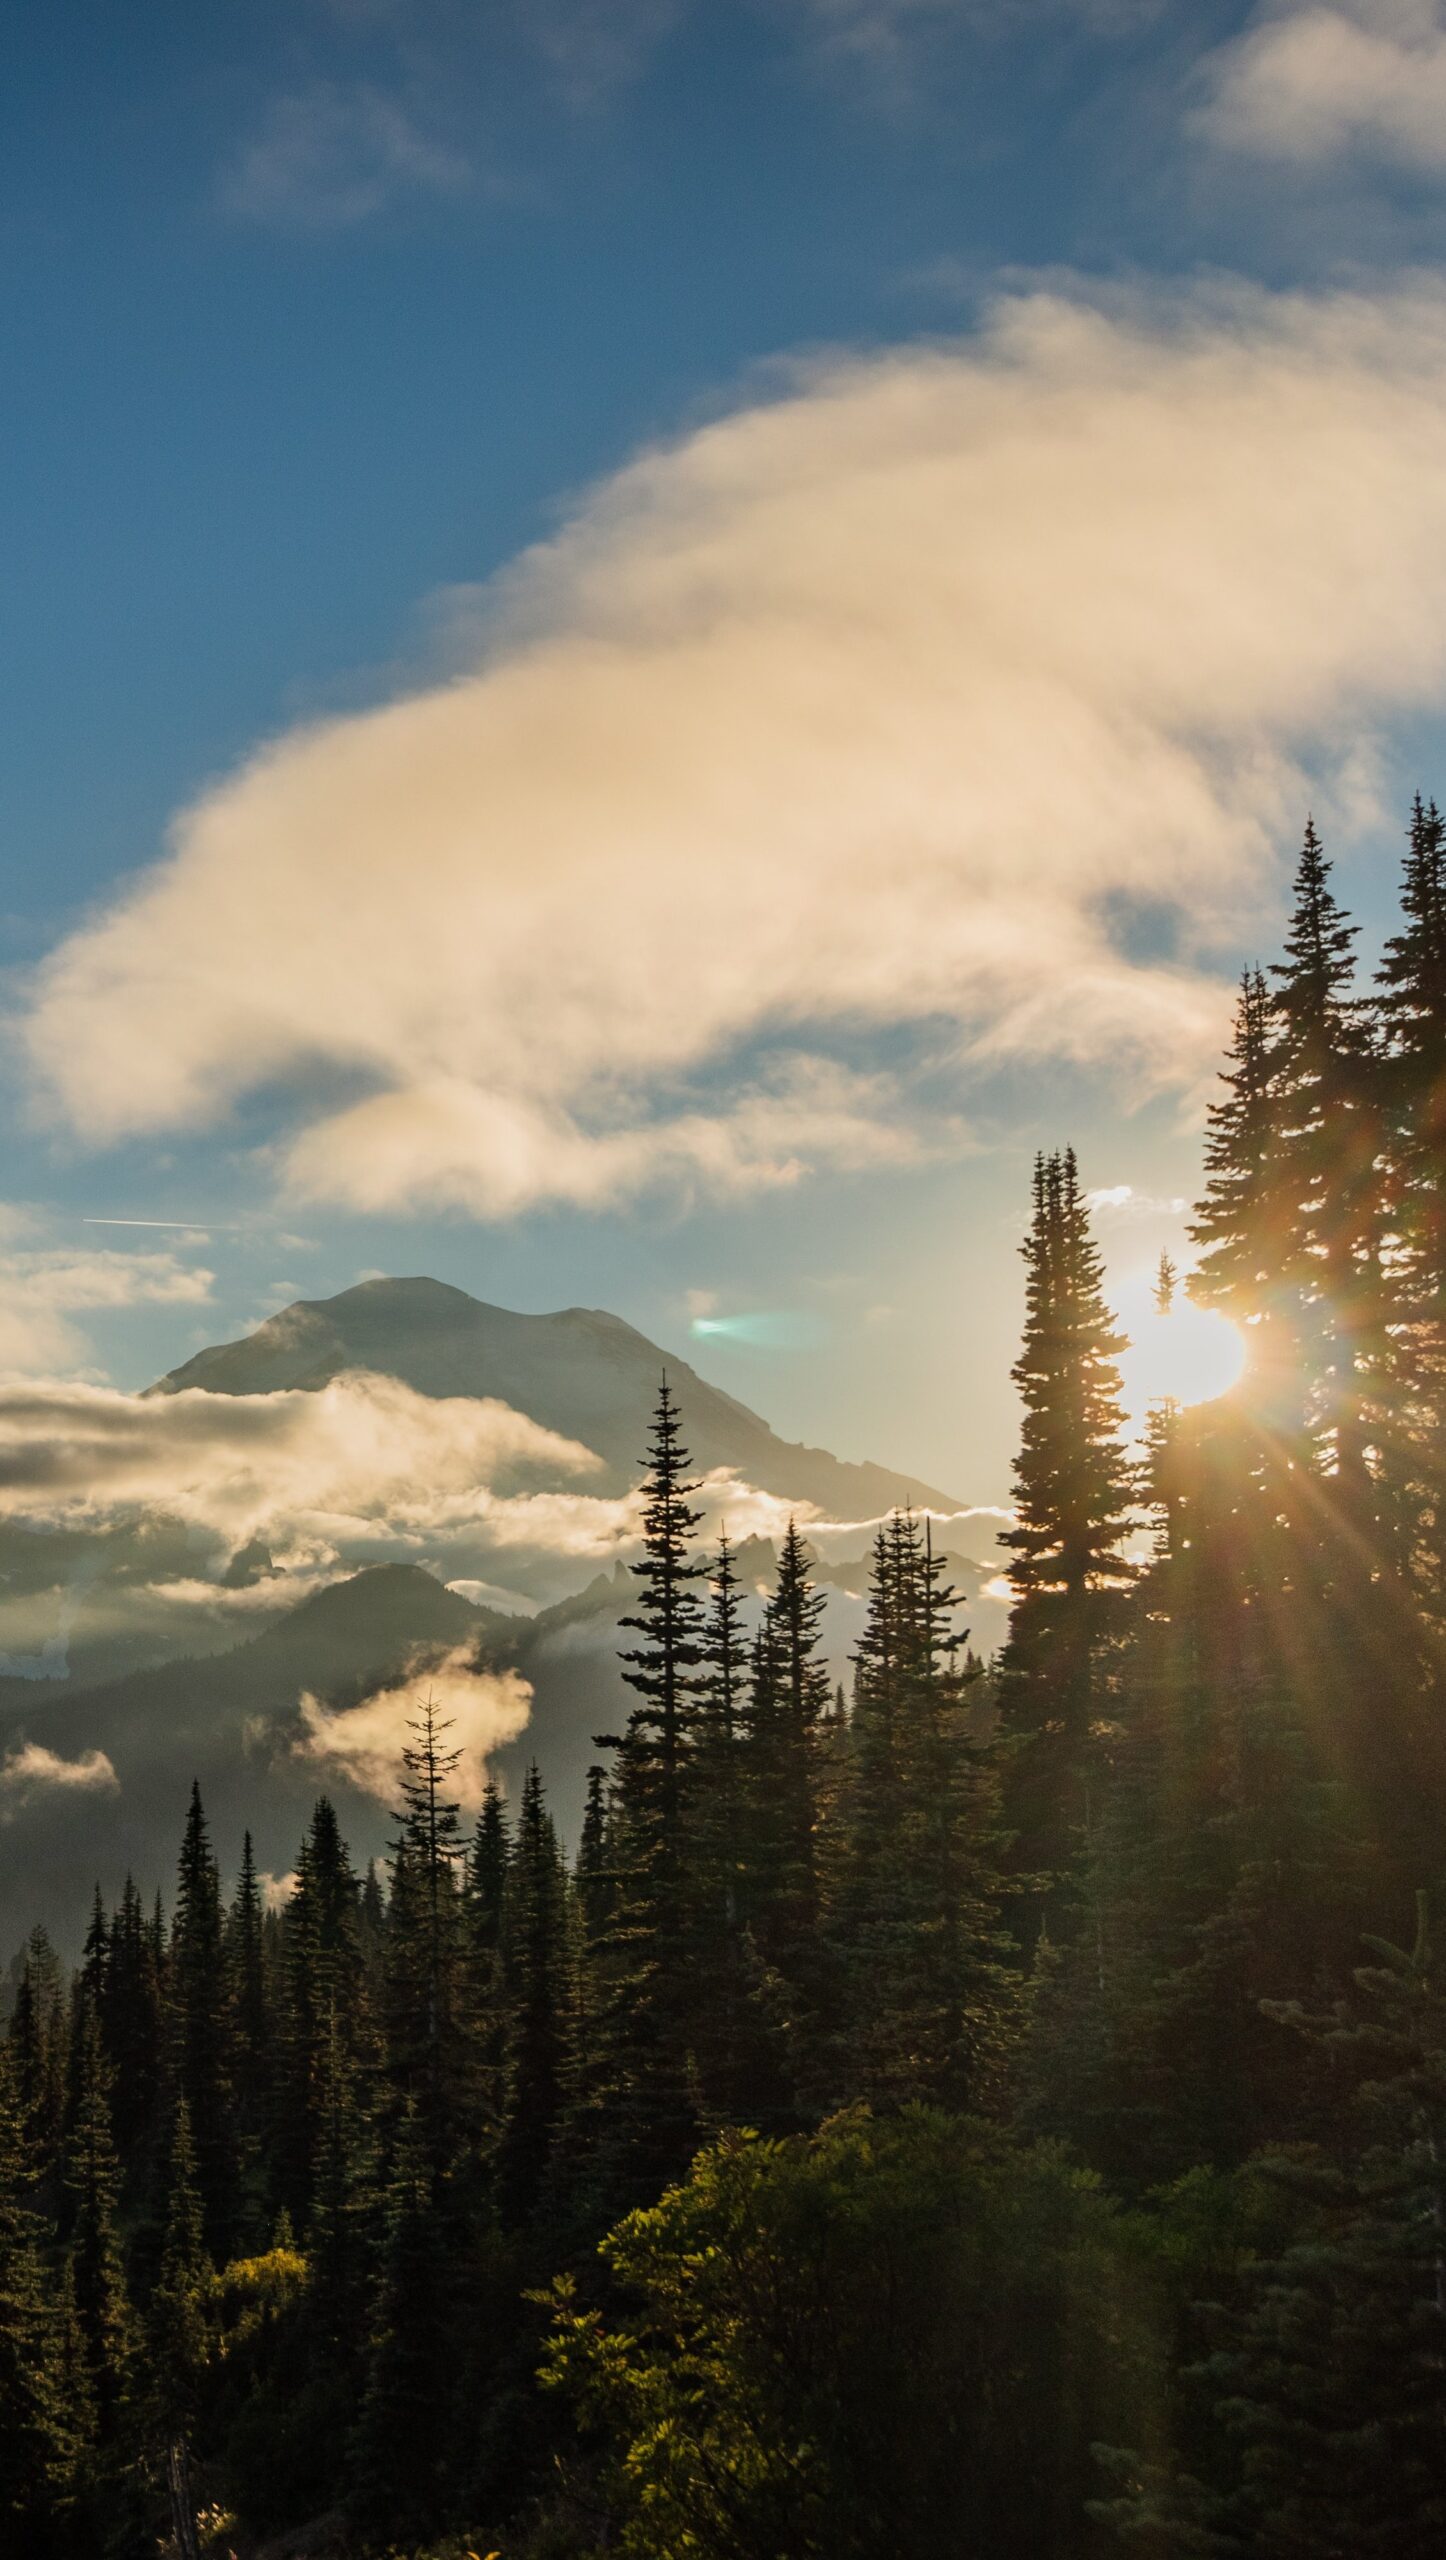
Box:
[26,287,1446,1216]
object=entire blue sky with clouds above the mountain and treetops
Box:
[0,0,1446,1503]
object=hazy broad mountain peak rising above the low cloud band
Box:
[151,1280,960,1521]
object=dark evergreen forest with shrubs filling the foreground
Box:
[0,804,1446,2560]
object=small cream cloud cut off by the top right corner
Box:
[1198,0,1446,174]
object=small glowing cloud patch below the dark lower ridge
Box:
[292,1646,532,1812]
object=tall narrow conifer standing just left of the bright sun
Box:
[1001,1149,1134,1935]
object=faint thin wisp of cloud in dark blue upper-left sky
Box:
[220,79,473,230]
